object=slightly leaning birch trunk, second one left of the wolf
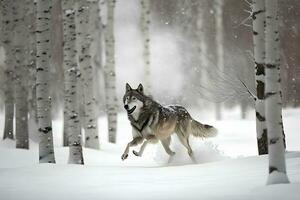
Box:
[76,0,99,149]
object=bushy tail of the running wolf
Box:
[191,120,218,138]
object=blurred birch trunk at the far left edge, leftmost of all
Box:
[0,0,14,139]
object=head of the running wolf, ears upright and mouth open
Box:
[123,83,147,118]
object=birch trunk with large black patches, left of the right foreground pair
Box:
[252,0,268,155]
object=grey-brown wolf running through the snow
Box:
[121,83,217,161]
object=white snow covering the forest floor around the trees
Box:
[0,109,300,200]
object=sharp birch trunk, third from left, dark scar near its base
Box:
[36,0,55,163]
